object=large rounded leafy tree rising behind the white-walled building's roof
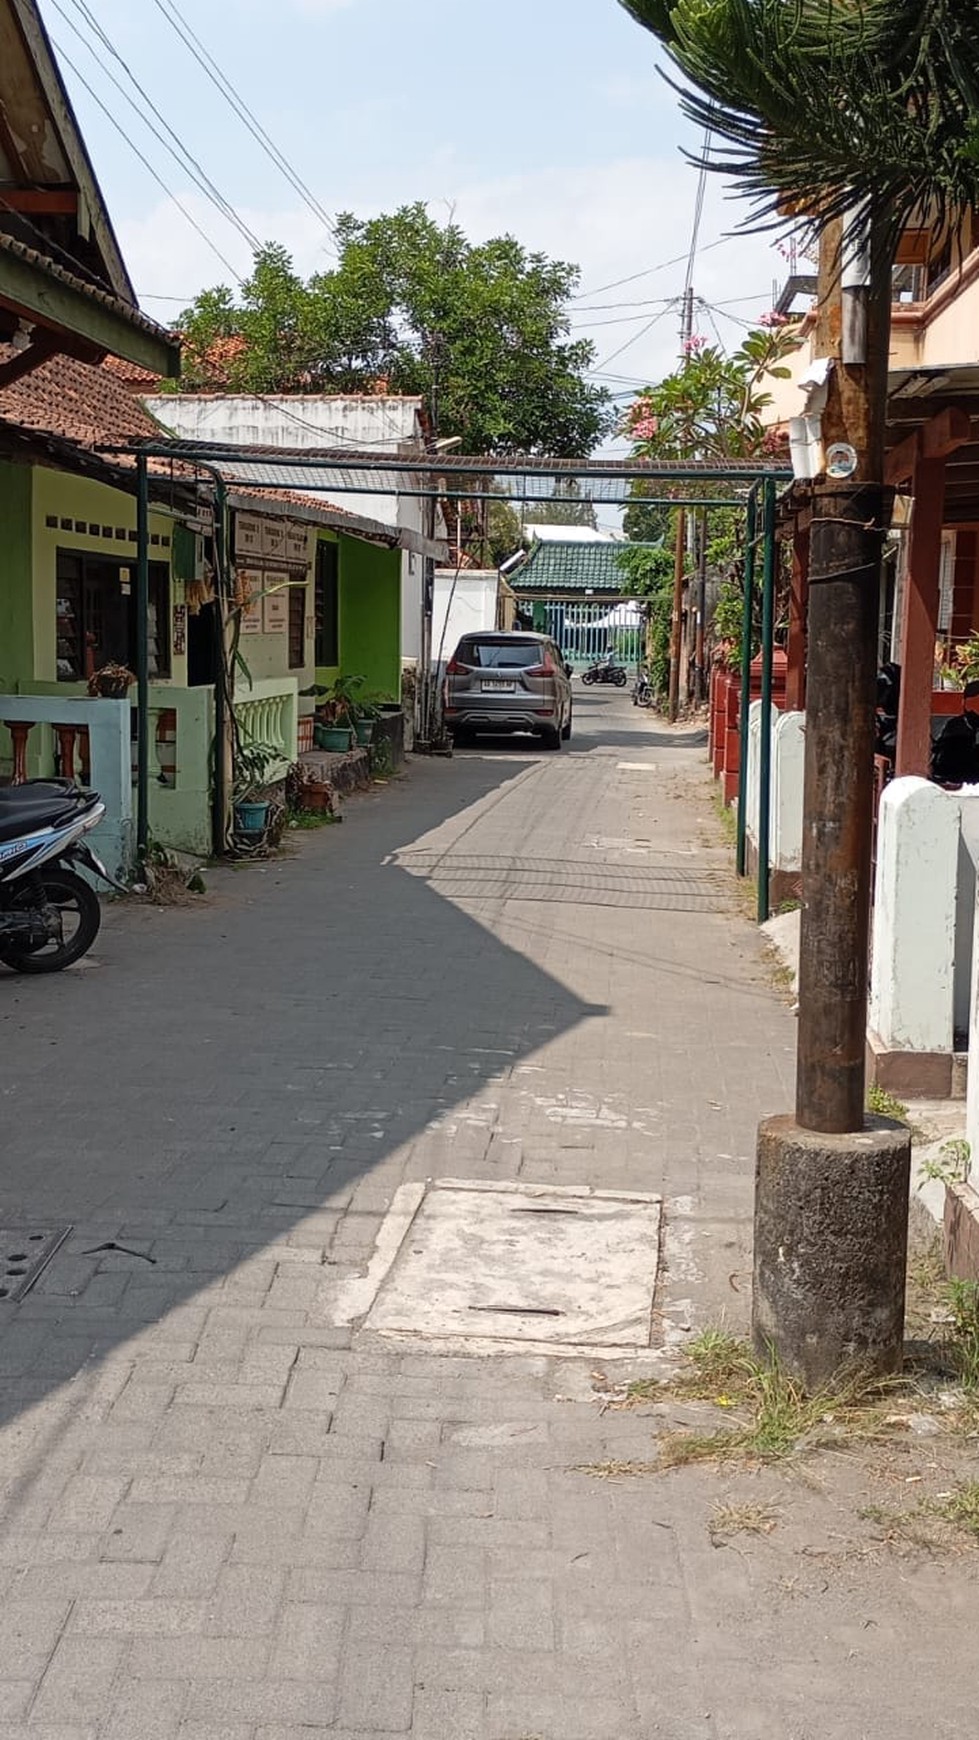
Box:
[169,204,612,456]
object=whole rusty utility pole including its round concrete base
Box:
[753,223,911,1387]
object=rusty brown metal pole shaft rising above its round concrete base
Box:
[796,214,890,1134]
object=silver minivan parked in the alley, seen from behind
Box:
[443,630,572,750]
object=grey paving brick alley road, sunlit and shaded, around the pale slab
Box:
[0,696,976,1740]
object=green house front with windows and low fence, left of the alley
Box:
[0,357,400,856]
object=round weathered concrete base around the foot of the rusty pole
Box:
[751,1117,911,1390]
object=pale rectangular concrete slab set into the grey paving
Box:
[348,1178,663,1354]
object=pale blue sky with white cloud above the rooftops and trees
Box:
[40,0,784,405]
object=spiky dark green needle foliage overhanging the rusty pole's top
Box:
[621,0,979,252]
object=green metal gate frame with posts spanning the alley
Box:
[114,437,793,922]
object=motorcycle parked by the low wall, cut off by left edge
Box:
[0,780,120,973]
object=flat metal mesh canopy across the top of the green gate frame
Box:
[104,440,791,506]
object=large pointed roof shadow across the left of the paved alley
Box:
[0,757,603,1440]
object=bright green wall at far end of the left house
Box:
[333,534,402,701]
